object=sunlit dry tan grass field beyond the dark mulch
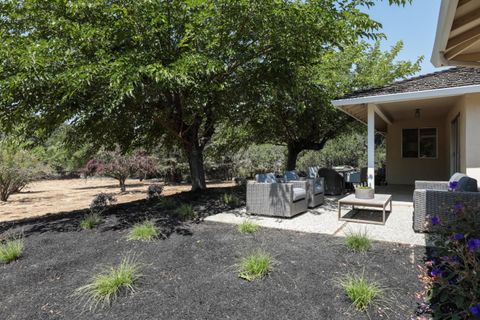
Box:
[0,178,233,222]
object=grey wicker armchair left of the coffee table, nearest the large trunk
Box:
[247,173,308,218]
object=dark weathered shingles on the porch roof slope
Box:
[340,67,480,99]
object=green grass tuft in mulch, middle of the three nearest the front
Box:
[239,251,273,281]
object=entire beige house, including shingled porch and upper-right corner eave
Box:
[333,0,480,186]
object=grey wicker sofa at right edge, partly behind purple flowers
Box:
[413,173,480,232]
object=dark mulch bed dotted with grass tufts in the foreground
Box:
[0,190,425,319]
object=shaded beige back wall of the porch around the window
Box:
[387,116,449,184]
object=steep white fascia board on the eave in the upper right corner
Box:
[430,0,458,67]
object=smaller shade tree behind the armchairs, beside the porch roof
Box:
[231,41,422,170]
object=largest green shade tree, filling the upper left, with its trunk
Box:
[0,0,412,190]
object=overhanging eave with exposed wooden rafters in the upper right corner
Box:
[431,0,480,67]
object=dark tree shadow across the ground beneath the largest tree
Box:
[0,187,245,238]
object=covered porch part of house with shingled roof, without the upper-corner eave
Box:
[333,68,480,186]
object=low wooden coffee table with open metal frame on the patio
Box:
[338,194,392,225]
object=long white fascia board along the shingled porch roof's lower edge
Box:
[332,84,480,107]
